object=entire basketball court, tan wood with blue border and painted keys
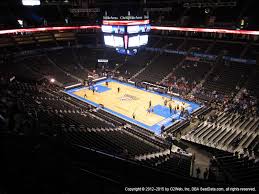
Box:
[65,79,200,134]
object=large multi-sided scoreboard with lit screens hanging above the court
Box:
[102,17,151,54]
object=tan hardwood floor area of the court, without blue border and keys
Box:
[73,82,189,126]
